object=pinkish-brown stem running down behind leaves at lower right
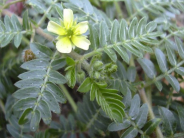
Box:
[139,89,164,138]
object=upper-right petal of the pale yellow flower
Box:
[74,21,88,35]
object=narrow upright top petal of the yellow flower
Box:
[63,9,73,29]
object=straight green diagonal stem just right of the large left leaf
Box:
[59,85,77,112]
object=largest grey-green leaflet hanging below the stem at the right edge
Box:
[165,75,180,92]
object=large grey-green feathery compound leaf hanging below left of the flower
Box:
[13,43,66,131]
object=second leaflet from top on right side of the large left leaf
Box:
[49,70,67,84]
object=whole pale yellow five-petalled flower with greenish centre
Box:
[47,9,90,53]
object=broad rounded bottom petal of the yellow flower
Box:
[56,37,72,53]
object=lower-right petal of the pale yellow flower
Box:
[72,36,91,50]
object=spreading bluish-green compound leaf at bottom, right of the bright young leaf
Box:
[108,90,160,138]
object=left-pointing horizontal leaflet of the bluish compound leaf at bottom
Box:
[108,120,131,131]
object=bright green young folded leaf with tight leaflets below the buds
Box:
[78,78,125,122]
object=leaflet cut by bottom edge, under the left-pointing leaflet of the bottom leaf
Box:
[120,127,138,138]
